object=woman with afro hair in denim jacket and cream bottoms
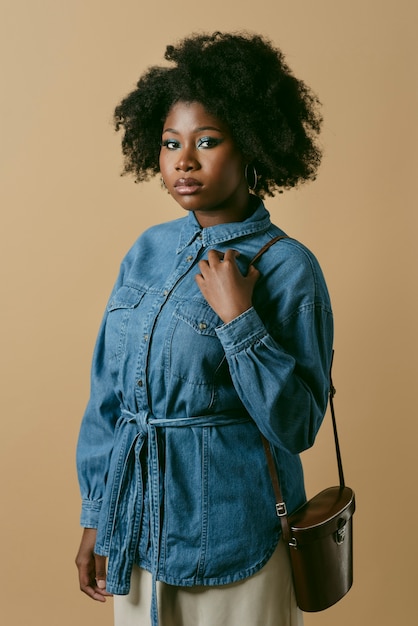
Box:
[77,33,332,626]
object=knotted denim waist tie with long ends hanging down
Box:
[95,409,250,626]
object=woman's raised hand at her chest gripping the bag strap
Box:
[196,250,260,324]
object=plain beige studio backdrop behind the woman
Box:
[0,0,418,626]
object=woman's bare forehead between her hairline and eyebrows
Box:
[163,101,228,133]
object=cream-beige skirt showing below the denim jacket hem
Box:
[114,541,303,626]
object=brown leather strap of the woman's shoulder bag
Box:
[250,235,345,543]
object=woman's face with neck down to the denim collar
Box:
[160,102,249,227]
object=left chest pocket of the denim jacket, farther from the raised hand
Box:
[106,285,144,360]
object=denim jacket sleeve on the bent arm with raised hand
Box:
[217,243,333,454]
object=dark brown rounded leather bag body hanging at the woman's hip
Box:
[288,486,355,612]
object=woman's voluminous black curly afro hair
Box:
[114,32,322,197]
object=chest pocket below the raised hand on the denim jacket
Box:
[169,300,227,386]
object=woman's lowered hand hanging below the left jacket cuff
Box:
[75,528,112,602]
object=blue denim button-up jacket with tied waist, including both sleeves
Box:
[77,203,332,608]
